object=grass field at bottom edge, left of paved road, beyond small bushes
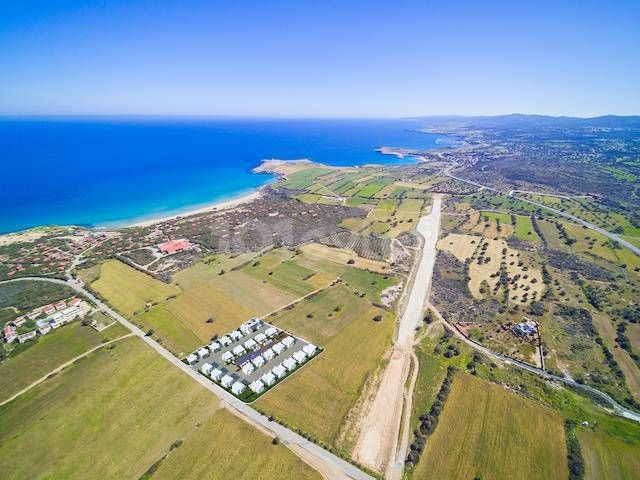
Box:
[153,410,322,480]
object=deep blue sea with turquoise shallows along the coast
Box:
[0,119,451,233]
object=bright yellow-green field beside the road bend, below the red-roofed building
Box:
[91,260,181,317]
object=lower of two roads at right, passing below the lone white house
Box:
[431,307,640,422]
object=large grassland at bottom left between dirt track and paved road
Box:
[0,338,318,479]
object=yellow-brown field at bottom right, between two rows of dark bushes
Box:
[413,374,568,480]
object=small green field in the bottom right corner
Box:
[576,428,640,480]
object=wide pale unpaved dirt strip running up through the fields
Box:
[354,195,442,478]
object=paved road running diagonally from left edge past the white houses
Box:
[0,277,373,480]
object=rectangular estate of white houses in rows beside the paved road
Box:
[185,318,322,402]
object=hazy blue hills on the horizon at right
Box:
[408,113,640,129]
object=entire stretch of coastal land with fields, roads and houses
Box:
[0,116,640,480]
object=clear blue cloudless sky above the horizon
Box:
[0,0,640,117]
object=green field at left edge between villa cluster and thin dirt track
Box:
[0,322,128,400]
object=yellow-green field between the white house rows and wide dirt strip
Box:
[256,286,395,446]
